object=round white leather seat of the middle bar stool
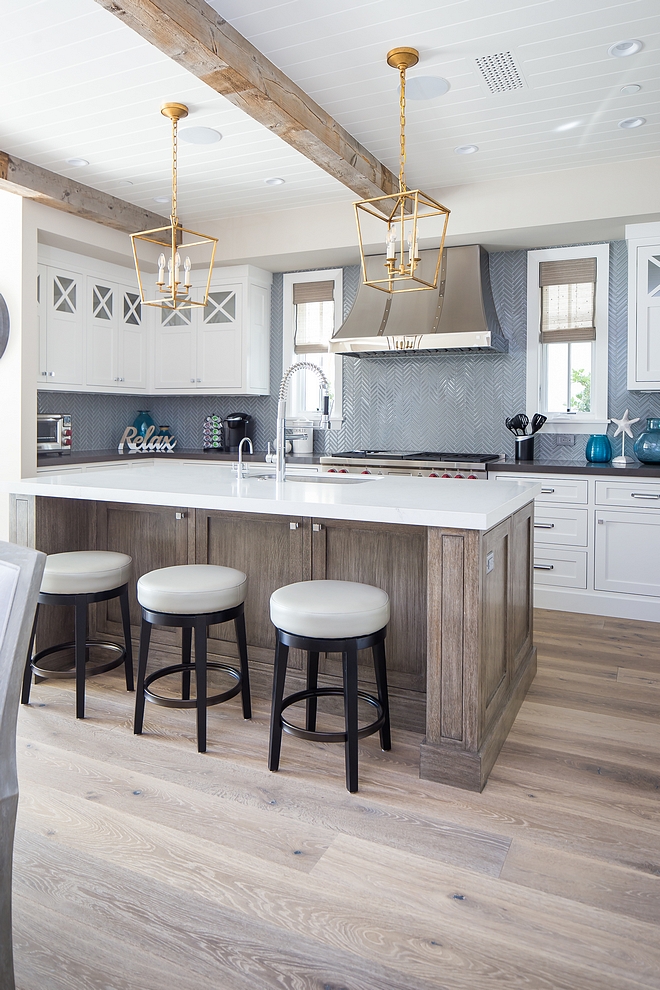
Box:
[137,564,247,615]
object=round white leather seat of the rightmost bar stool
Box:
[270,581,390,639]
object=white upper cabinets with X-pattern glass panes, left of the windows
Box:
[37,248,272,395]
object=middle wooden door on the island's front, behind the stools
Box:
[195,509,310,672]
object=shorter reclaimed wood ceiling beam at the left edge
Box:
[0,151,169,234]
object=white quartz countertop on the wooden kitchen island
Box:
[5,461,540,530]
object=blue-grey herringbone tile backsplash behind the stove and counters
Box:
[39,241,660,462]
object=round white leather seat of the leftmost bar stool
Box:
[41,550,133,595]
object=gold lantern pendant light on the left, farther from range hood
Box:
[131,103,218,310]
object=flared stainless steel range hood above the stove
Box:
[330,244,509,357]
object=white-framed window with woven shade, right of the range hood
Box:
[527,244,609,433]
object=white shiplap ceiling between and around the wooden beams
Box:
[0,0,660,225]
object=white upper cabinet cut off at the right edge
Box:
[626,223,660,392]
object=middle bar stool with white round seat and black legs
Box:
[133,564,252,753]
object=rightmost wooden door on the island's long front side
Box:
[312,519,426,696]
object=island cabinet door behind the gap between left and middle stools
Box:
[96,502,190,646]
